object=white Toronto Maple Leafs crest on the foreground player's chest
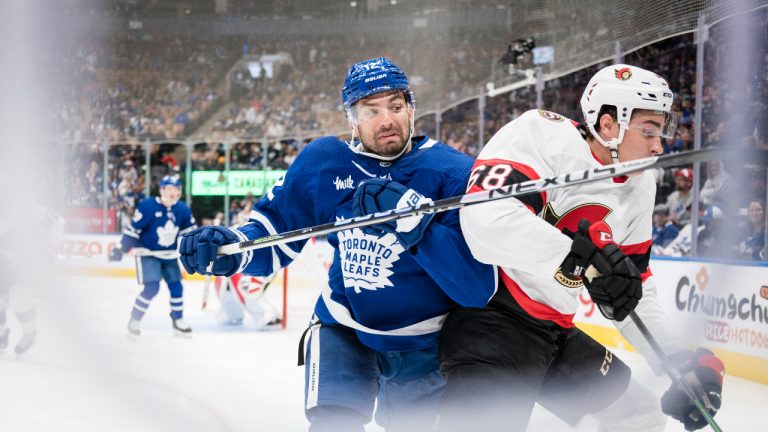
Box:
[339,228,404,294]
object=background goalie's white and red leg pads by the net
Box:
[215,273,282,330]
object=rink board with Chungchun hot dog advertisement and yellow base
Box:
[574,258,768,383]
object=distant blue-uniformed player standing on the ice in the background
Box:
[109,175,197,338]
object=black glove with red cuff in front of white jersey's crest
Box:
[560,219,643,321]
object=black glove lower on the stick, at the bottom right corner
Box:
[661,348,725,431]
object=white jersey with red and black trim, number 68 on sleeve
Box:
[460,110,683,359]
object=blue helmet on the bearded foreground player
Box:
[341,57,416,111]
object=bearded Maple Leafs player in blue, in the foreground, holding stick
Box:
[179,58,496,431]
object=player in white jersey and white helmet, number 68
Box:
[440,65,723,431]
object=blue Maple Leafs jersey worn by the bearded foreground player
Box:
[238,137,496,351]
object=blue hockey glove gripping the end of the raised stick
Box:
[179,226,243,276]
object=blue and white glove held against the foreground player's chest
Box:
[352,178,435,249]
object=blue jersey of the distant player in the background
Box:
[121,197,197,251]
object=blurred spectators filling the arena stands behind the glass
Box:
[63,14,768,259]
